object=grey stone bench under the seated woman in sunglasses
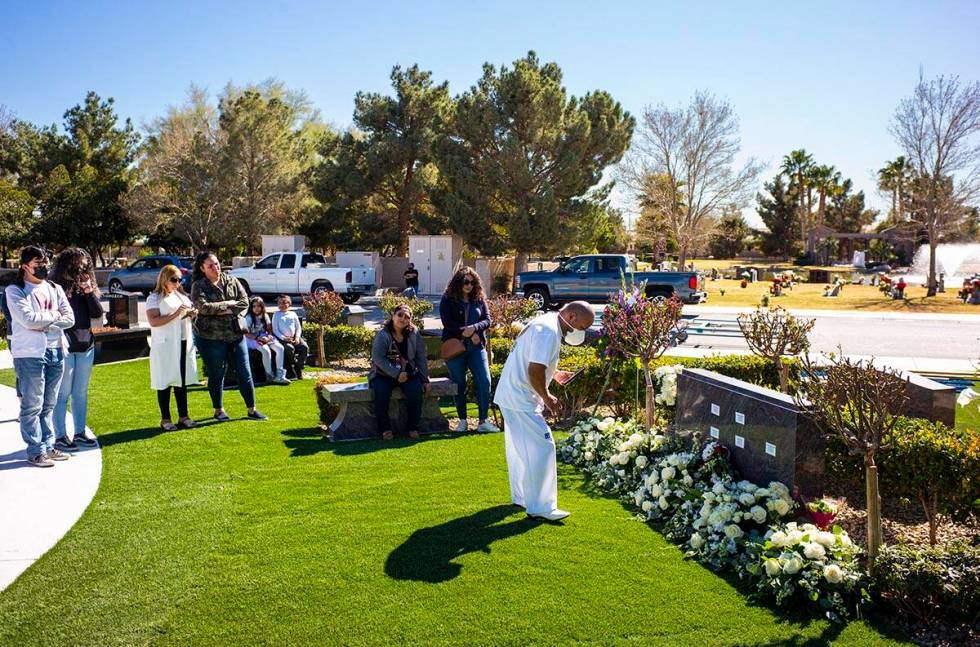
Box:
[319,377,456,442]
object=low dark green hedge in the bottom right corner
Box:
[872,544,980,624]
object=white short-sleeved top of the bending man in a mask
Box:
[493,312,562,411]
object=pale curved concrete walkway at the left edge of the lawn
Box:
[0,386,102,591]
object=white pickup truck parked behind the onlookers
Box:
[231,252,375,303]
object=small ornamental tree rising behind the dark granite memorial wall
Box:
[738,307,814,393]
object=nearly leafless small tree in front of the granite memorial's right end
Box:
[796,355,908,562]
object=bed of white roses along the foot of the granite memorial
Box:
[558,418,869,621]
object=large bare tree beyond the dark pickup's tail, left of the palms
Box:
[620,92,763,265]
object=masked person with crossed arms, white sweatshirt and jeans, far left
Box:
[6,245,75,466]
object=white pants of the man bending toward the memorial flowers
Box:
[500,408,558,514]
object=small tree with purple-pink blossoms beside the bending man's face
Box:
[598,285,683,429]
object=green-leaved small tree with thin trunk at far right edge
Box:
[881,418,980,546]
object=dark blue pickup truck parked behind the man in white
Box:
[514,254,707,308]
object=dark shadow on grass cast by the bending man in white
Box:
[385,505,545,584]
